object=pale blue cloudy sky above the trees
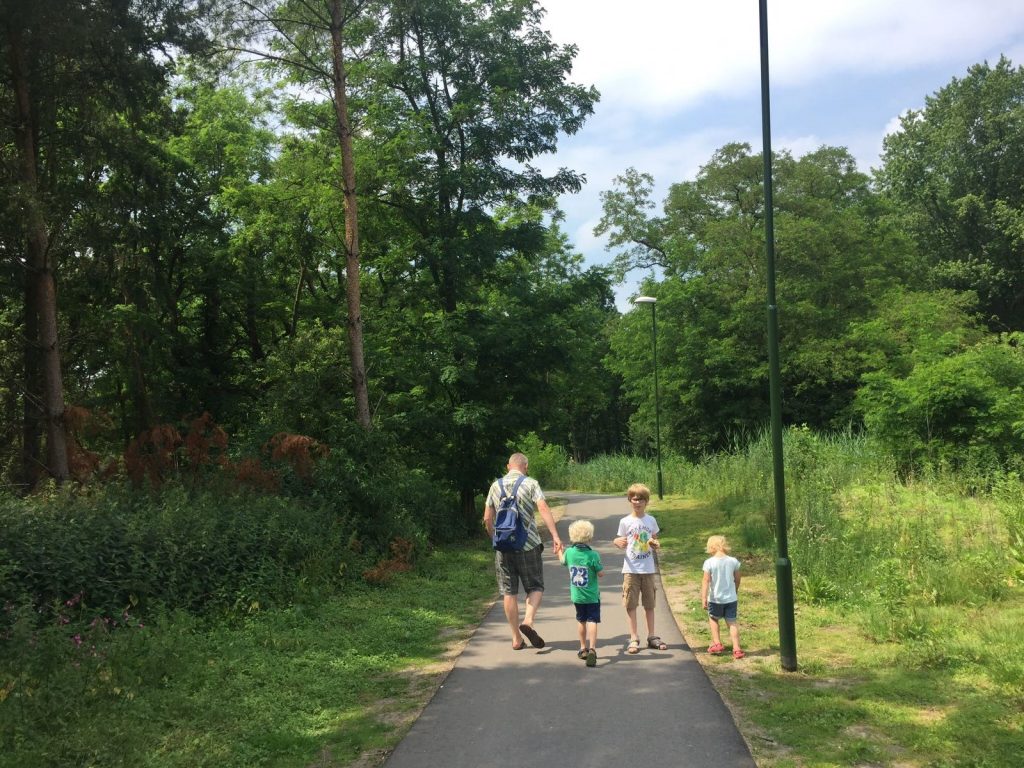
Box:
[538,0,1024,310]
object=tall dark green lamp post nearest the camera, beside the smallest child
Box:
[759,0,797,672]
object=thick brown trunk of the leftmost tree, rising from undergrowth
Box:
[7,28,70,482]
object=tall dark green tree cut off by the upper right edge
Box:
[878,57,1024,330]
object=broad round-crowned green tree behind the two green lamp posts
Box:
[599,143,913,456]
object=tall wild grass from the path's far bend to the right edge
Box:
[531,428,1024,639]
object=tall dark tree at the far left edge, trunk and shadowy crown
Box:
[0,0,209,483]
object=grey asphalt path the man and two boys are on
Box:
[385,496,755,768]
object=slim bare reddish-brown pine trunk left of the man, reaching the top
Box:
[331,0,370,429]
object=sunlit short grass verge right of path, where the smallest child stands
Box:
[652,498,1024,768]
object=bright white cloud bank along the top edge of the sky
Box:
[542,0,1024,110]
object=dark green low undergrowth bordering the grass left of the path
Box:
[0,484,342,615]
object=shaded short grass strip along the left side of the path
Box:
[0,547,494,768]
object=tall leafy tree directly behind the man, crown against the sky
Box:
[364,0,597,518]
